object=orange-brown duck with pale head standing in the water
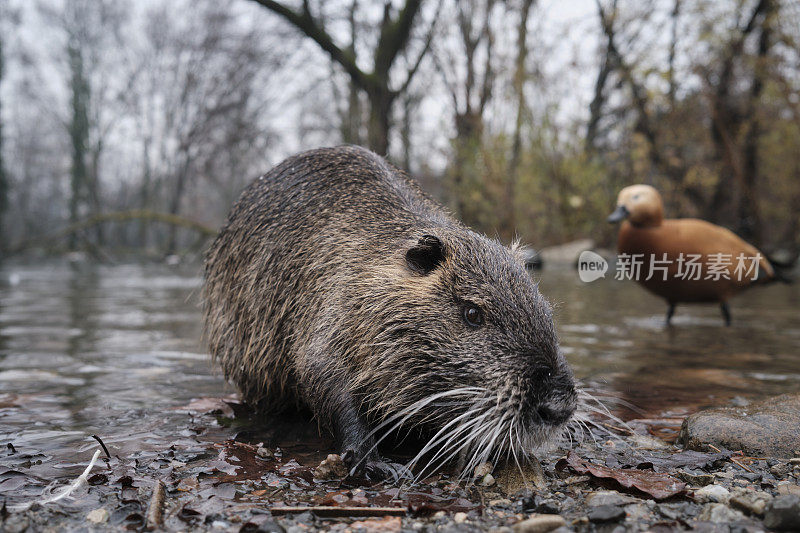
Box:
[609,185,775,324]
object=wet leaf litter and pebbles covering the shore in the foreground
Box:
[0,392,800,532]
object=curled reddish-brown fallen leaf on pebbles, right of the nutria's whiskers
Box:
[556,452,686,500]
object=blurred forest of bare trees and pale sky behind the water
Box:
[0,0,800,257]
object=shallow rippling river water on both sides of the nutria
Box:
[0,263,800,502]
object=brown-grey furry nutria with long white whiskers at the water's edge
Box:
[204,146,576,474]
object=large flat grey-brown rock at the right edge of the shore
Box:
[679,394,800,459]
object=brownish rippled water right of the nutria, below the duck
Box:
[542,271,800,418]
